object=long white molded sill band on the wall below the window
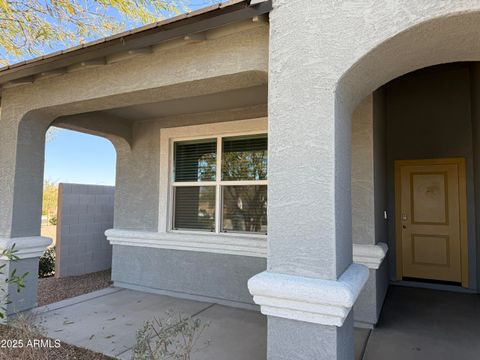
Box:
[105,229,267,258]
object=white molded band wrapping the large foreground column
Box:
[248,264,368,327]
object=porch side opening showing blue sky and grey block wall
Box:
[38,126,116,306]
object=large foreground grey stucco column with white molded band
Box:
[249,0,368,360]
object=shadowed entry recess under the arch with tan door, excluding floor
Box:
[352,62,478,290]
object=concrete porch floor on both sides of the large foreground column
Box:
[32,286,480,360]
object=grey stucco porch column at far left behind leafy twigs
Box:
[0,110,51,314]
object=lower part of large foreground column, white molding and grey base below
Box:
[248,264,368,360]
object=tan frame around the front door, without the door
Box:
[394,157,468,288]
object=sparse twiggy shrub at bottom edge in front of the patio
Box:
[132,313,209,360]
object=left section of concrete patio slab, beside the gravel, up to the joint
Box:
[34,290,211,357]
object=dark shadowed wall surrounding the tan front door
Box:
[386,64,477,288]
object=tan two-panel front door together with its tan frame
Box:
[395,158,467,286]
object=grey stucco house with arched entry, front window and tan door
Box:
[0,0,480,359]
